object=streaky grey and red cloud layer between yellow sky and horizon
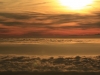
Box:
[0,12,100,37]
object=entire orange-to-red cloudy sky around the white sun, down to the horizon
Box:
[0,0,100,37]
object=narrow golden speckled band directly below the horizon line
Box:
[0,38,100,44]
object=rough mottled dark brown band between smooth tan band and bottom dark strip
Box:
[0,55,100,72]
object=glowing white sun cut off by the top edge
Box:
[59,0,93,10]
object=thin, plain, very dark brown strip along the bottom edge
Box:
[0,72,100,75]
